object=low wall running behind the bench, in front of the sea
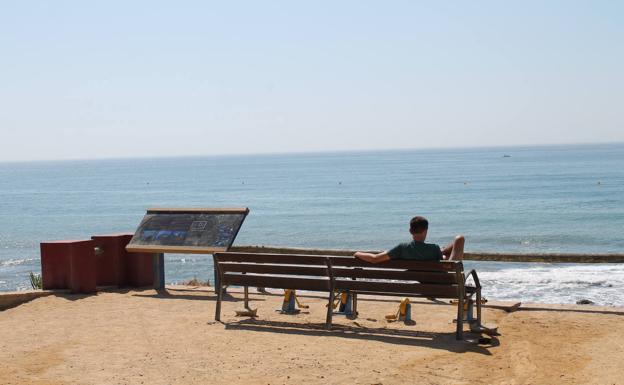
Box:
[230,246,624,263]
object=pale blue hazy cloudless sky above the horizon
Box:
[0,0,624,160]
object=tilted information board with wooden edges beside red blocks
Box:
[128,208,249,252]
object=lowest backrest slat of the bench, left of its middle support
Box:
[222,273,329,291]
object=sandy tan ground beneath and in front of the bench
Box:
[0,287,624,385]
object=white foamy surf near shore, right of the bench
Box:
[479,264,624,306]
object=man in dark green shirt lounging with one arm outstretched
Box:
[353,217,465,263]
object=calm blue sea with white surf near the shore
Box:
[0,144,624,306]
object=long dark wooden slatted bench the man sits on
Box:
[214,252,481,339]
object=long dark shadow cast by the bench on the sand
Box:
[224,318,500,355]
